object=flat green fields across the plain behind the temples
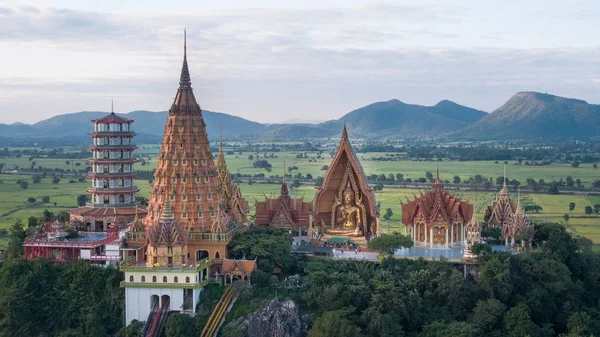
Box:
[0,145,600,245]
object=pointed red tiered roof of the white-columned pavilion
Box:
[402,170,474,225]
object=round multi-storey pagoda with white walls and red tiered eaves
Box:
[68,106,146,231]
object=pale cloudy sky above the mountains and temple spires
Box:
[0,0,600,123]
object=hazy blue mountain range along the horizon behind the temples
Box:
[0,92,600,143]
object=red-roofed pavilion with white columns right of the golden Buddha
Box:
[402,170,474,248]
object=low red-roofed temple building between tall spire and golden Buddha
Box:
[255,165,312,240]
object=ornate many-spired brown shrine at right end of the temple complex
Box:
[484,167,530,246]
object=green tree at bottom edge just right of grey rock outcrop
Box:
[308,309,362,337]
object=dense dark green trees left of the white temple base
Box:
[0,259,124,337]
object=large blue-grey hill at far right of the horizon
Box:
[456,92,600,140]
